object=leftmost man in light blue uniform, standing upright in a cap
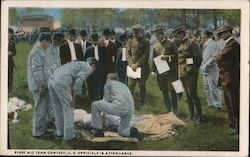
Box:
[27,33,52,138]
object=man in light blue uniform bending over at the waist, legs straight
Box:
[48,61,95,140]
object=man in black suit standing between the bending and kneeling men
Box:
[85,34,105,102]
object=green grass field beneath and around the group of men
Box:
[9,42,239,151]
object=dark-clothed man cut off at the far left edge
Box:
[8,28,16,93]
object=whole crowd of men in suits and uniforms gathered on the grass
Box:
[9,24,240,140]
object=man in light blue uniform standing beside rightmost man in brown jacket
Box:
[200,30,222,112]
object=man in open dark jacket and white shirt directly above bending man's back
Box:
[60,28,83,65]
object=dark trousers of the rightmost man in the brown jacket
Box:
[223,83,240,131]
